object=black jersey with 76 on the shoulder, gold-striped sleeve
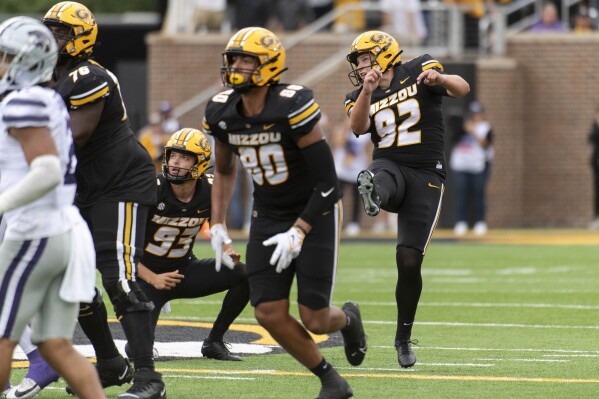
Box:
[55,60,155,206]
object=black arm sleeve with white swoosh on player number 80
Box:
[300,140,340,225]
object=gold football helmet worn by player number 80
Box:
[221,27,286,90]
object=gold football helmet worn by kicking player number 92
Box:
[347,30,403,86]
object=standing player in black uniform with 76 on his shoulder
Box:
[42,1,165,398]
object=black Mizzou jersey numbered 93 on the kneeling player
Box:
[141,174,212,271]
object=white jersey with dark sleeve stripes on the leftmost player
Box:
[0,86,77,240]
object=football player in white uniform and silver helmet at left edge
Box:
[0,17,105,398]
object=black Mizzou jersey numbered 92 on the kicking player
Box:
[345,54,448,177]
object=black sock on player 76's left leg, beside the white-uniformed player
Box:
[78,293,119,360]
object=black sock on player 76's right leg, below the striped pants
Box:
[121,311,154,371]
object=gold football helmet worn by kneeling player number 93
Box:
[162,128,212,184]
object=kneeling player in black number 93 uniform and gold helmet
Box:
[138,129,250,361]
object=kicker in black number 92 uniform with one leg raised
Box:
[345,31,470,367]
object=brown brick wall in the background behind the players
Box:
[147,34,599,227]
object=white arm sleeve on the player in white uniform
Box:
[0,155,62,214]
